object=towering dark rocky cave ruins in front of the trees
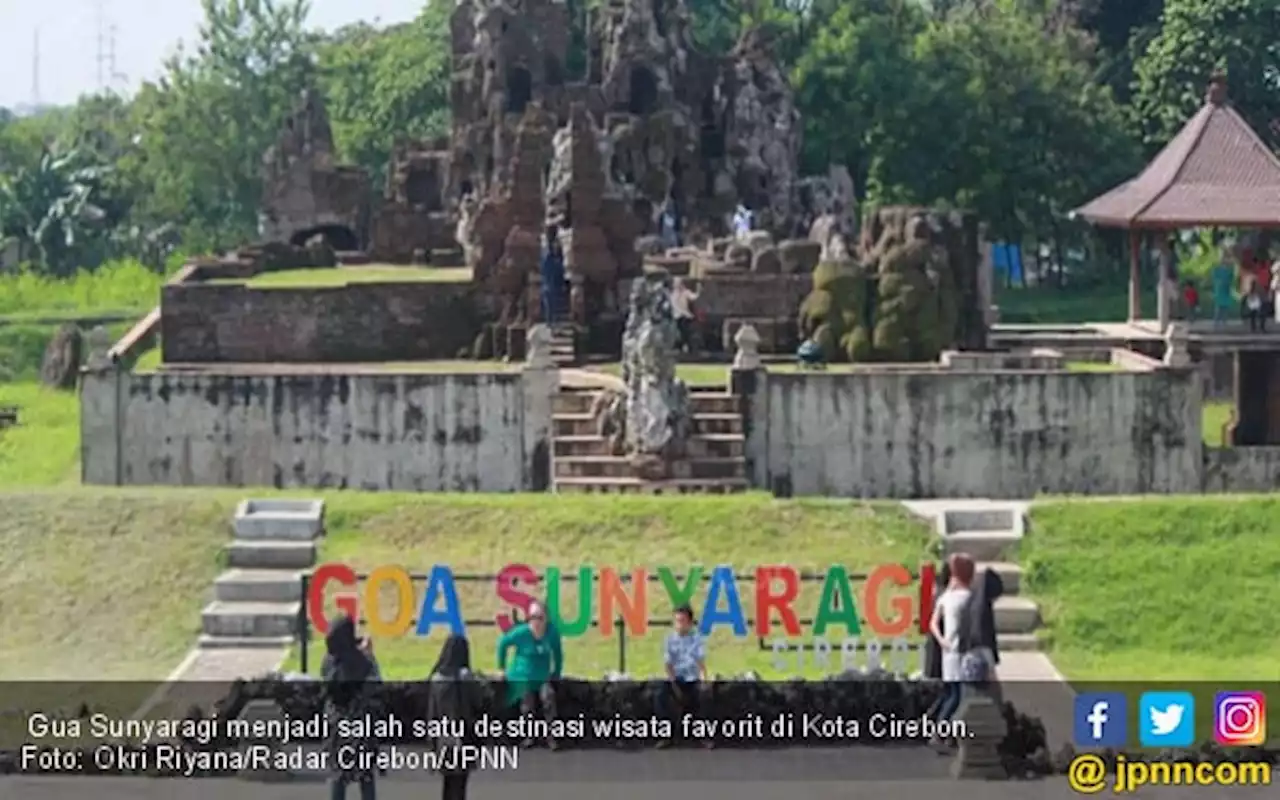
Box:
[262,0,855,349]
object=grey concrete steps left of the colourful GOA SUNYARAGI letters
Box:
[198,499,324,649]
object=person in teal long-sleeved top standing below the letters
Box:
[498,603,564,750]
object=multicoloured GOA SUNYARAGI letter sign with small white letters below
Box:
[307,563,936,672]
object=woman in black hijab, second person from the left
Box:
[426,636,484,800]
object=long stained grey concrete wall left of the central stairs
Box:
[81,369,556,492]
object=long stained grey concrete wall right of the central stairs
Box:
[746,369,1203,498]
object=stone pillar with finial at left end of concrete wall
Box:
[79,325,128,486]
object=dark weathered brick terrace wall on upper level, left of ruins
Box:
[160,277,483,364]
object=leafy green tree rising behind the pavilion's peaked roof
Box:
[1133,0,1280,148]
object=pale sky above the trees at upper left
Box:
[0,0,425,108]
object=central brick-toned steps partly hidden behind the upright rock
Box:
[552,387,750,494]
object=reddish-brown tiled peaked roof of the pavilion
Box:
[1075,87,1280,228]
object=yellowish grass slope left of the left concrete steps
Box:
[0,483,230,681]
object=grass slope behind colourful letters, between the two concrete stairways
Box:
[291,494,932,680]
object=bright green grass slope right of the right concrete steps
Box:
[1020,497,1280,732]
